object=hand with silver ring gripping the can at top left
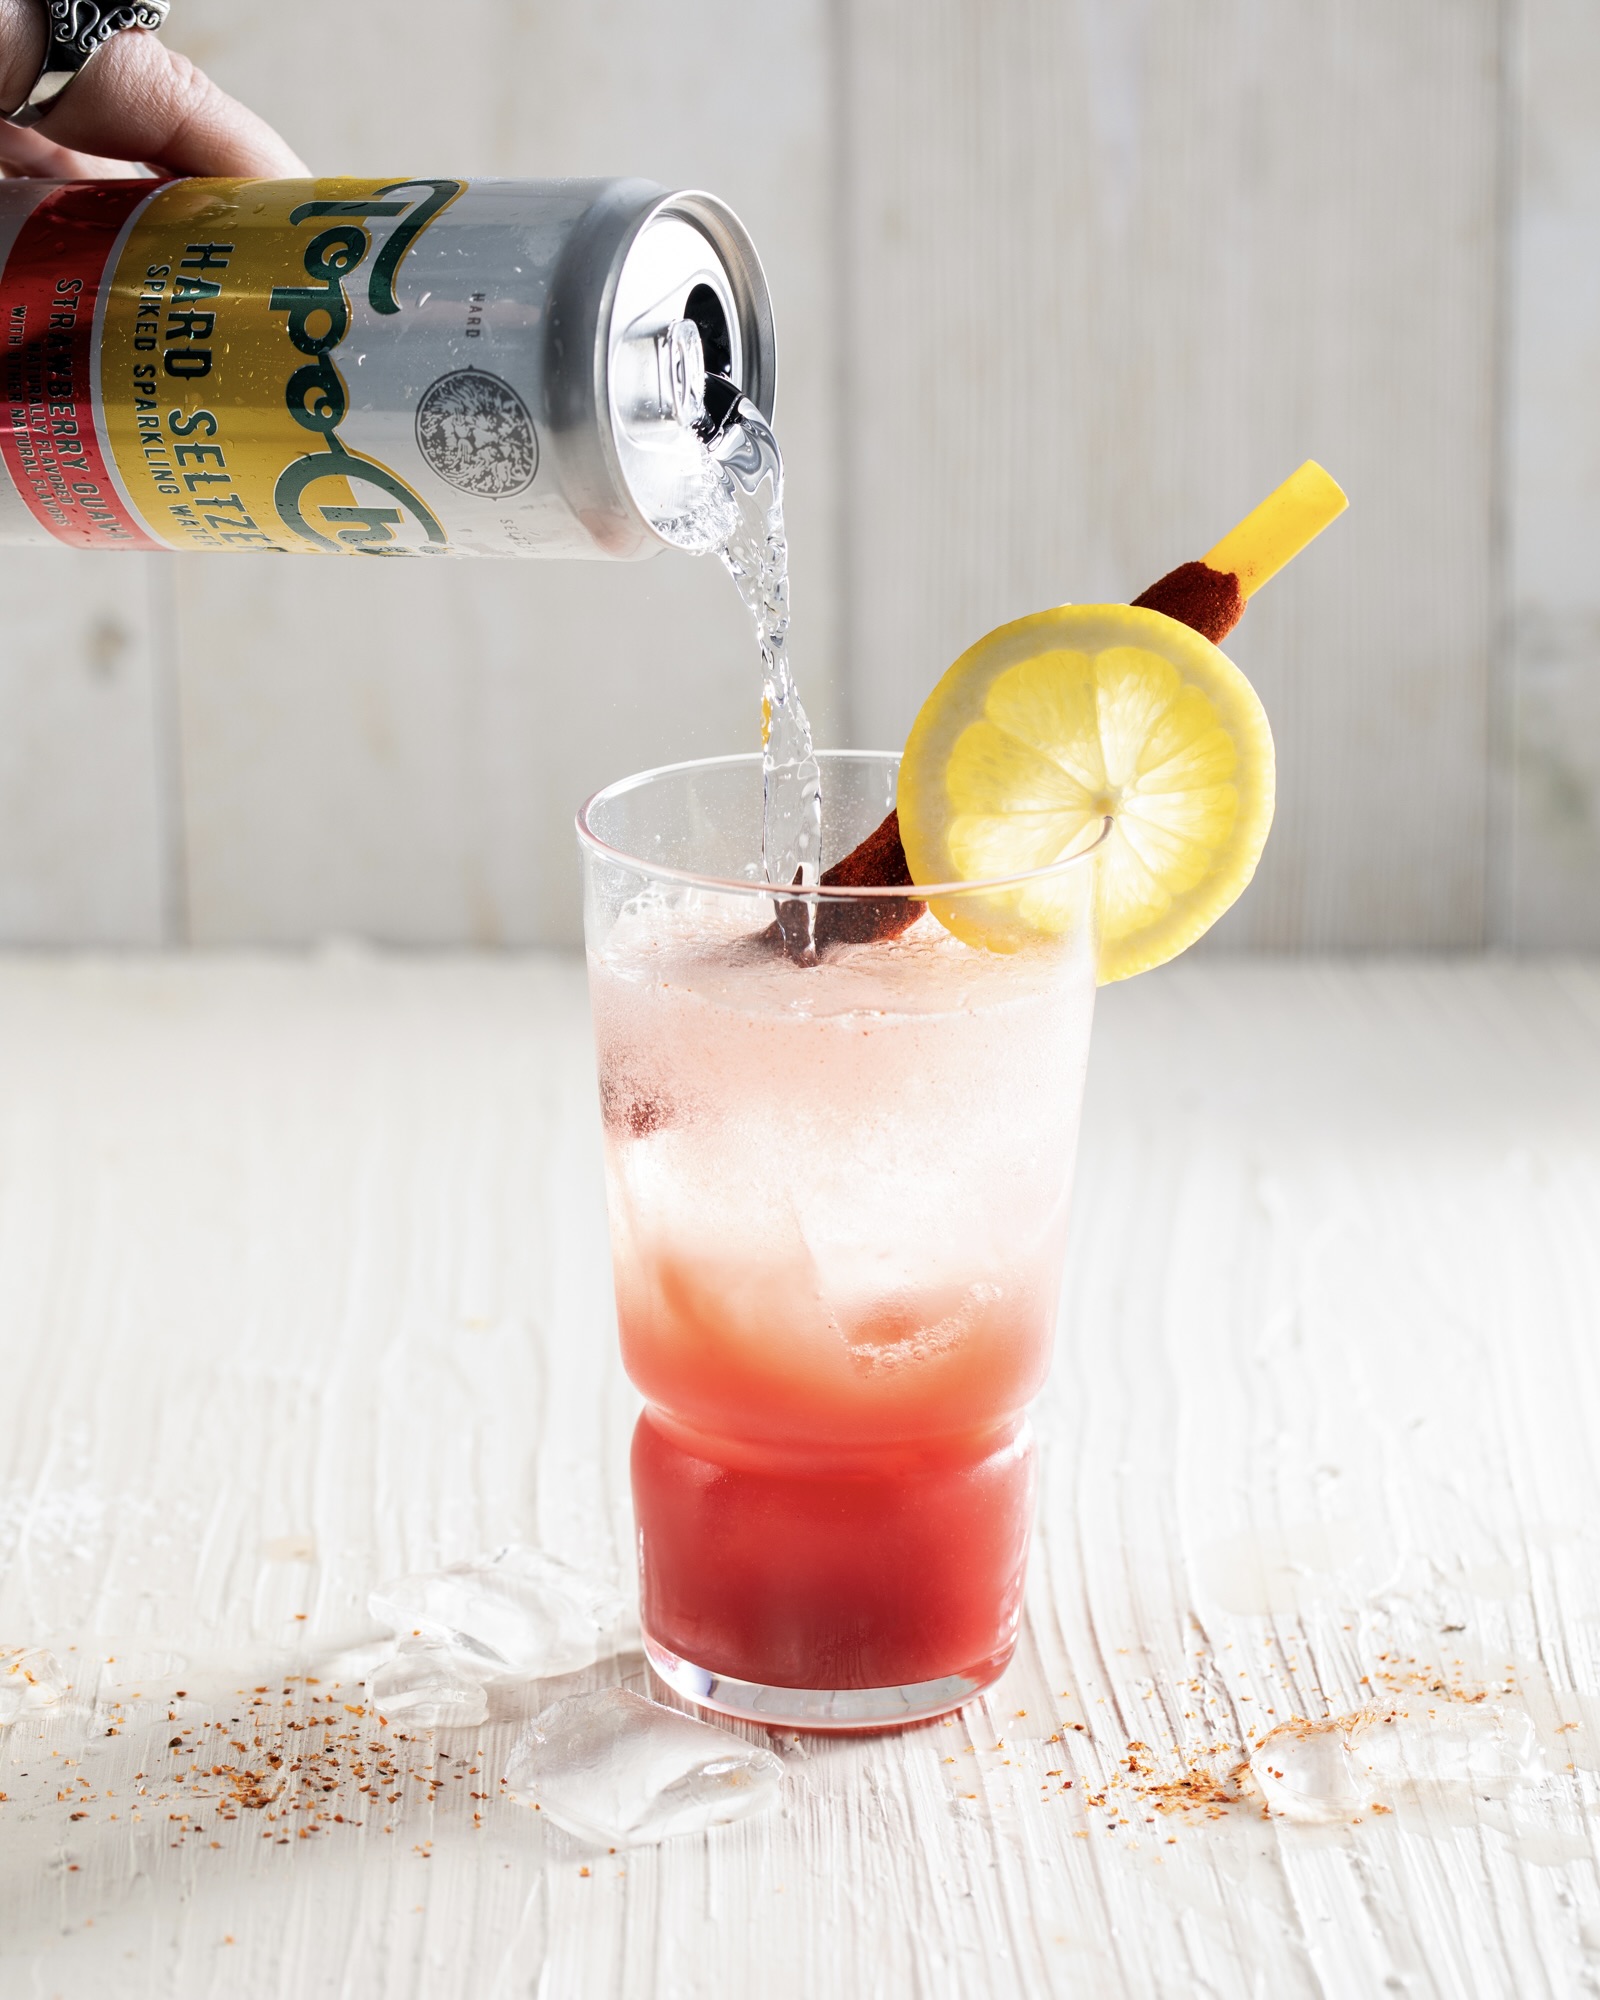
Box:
[0,0,306,180]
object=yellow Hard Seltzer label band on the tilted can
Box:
[100,180,466,554]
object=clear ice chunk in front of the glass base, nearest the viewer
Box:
[506,1688,784,1848]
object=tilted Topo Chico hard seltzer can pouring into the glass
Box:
[0,176,774,558]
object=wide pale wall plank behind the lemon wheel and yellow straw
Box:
[842,0,1500,948]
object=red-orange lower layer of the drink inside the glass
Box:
[618,1258,1054,1688]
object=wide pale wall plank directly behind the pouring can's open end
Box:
[170,0,836,944]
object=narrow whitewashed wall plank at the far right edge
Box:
[1496,0,1600,948]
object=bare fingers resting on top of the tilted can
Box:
[0,13,306,176]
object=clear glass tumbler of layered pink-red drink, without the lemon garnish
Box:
[578,752,1096,1730]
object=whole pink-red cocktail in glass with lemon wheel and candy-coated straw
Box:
[578,468,1344,1728]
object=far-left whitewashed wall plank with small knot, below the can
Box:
[0,548,182,944]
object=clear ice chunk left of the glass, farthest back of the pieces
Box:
[368,1544,624,1680]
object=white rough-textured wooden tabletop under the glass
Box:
[0,952,1600,2000]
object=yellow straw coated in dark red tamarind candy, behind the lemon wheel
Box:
[816,458,1350,948]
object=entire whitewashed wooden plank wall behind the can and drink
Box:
[0,0,1600,948]
